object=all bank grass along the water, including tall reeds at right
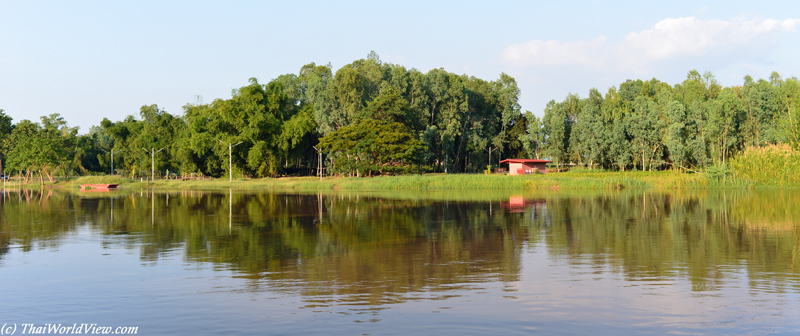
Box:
[12,151,800,191]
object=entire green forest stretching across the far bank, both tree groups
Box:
[0,52,800,182]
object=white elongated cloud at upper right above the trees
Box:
[503,16,800,73]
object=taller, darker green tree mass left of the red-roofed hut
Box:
[0,52,525,179]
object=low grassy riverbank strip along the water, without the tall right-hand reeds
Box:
[7,170,724,190]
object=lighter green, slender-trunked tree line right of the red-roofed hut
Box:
[521,70,800,170]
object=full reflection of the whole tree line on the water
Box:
[0,189,800,332]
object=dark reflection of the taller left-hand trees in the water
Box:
[0,190,525,304]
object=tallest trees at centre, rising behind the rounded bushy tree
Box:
[298,53,524,171]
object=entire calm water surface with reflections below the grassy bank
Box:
[0,190,800,335]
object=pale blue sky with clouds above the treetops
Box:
[0,0,800,133]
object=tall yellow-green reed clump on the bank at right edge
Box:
[729,145,800,188]
